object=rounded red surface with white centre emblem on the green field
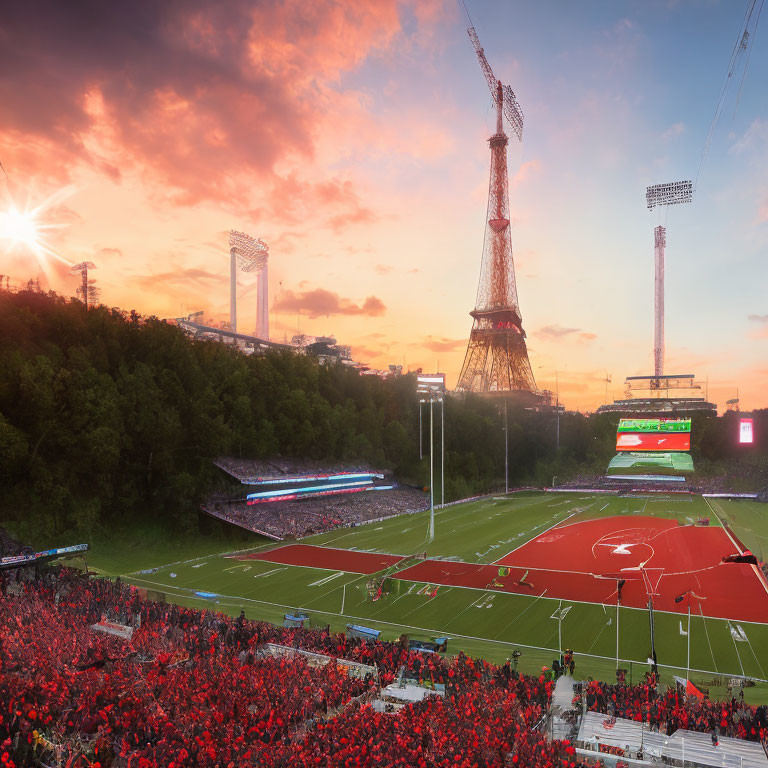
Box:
[396,517,768,623]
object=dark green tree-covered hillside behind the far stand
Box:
[0,292,768,536]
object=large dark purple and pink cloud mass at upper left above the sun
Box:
[0,0,408,210]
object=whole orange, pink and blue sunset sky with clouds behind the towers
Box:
[0,0,768,410]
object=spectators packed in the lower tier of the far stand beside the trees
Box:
[203,486,429,539]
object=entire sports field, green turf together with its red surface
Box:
[125,492,768,680]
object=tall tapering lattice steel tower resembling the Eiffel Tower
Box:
[456,28,540,402]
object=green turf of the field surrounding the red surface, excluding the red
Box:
[103,493,768,695]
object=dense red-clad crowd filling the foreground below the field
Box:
[0,569,766,768]
